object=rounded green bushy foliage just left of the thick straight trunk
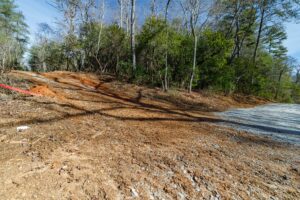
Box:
[81,23,129,74]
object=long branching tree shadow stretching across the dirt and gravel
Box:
[0,73,300,147]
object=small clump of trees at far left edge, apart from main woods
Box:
[0,0,28,73]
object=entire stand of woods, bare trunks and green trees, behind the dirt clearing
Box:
[0,0,300,101]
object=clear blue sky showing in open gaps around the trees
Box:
[15,0,300,62]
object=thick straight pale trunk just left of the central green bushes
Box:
[130,0,136,78]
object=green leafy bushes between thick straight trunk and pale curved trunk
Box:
[137,17,193,87]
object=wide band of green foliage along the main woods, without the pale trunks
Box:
[26,0,300,101]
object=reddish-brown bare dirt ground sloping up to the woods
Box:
[0,71,300,200]
